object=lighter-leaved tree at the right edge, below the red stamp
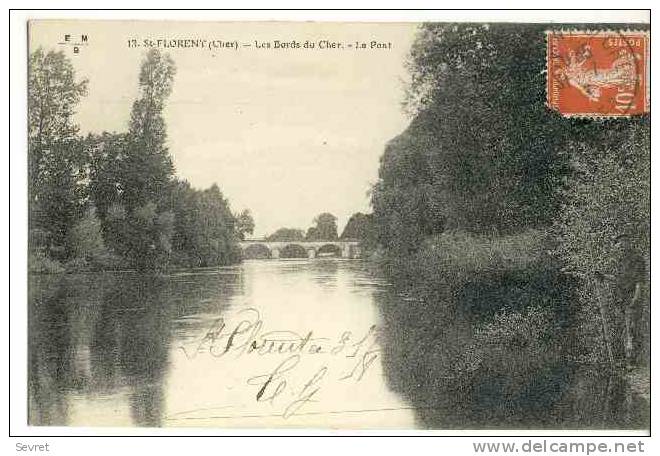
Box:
[555,117,651,368]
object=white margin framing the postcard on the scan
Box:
[0,1,658,455]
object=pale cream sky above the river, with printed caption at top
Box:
[30,21,417,237]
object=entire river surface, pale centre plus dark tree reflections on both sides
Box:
[28,259,639,429]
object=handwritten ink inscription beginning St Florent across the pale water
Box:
[179,308,380,418]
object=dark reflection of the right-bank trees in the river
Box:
[376,270,643,429]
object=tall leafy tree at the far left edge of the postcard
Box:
[28,48,87,256]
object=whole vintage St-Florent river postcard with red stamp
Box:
[25,19,651,433]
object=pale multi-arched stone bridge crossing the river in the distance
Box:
[238,239,362,258]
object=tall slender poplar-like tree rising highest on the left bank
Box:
[113,49,175,269]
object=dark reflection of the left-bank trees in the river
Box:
[28,268,243,426]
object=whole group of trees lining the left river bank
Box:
[28,48,254,272]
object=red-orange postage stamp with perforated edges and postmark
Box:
[547,31,650,117]
